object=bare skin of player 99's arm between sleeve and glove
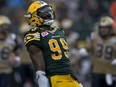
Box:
[27,45,45,71]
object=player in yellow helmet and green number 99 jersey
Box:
[25,1,82,87]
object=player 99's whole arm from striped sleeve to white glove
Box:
[24,30,49,87]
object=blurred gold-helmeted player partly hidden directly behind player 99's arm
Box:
[19,22,35,87]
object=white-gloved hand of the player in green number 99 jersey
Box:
[36,71,49,87]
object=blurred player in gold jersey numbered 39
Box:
[86,16,116,87]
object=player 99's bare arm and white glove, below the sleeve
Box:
[27,45,49,87]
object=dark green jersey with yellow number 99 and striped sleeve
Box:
[25,27,75,75]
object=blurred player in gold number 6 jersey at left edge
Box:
[0,15,20,87]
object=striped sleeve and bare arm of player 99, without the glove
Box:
[24,28,45,71]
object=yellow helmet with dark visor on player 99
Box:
[25,1,55,26]
